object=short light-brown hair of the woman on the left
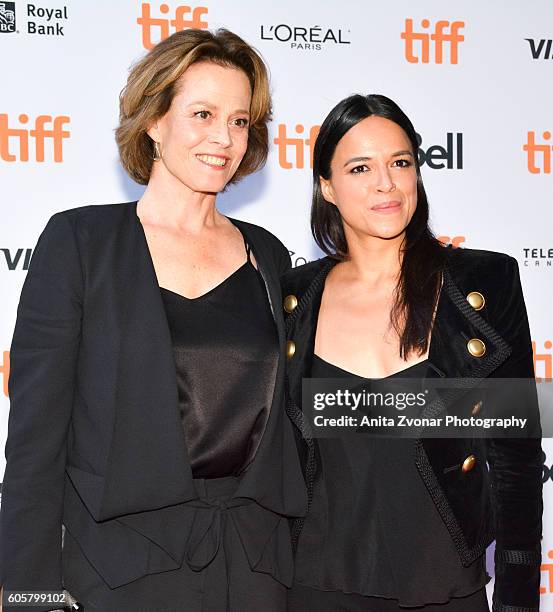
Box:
[115,29,272,185]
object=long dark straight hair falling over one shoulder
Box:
[311,94,445,359]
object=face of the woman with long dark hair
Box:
[320,116,417,244]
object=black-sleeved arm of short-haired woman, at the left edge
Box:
[0,214,83,612]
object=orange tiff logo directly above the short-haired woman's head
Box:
[136,2,208,49]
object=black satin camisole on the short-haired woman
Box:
[161,246,278,478]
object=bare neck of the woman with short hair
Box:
[137,162,225,233]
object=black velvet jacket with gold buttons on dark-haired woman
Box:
[283,249,542,612]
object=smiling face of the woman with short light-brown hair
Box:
[148,62,252,193]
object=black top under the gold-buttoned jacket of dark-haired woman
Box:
[295,355,487,610]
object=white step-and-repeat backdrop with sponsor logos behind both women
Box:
[0,0,553,611]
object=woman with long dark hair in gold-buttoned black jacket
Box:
[283,95,542,612]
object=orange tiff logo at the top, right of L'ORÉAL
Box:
[401,19,465,64]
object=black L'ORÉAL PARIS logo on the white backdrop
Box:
[260,23,351,51]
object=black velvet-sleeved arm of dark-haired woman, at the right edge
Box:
[488,258,542,612]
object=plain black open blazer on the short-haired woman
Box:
[0,203,307,611]
